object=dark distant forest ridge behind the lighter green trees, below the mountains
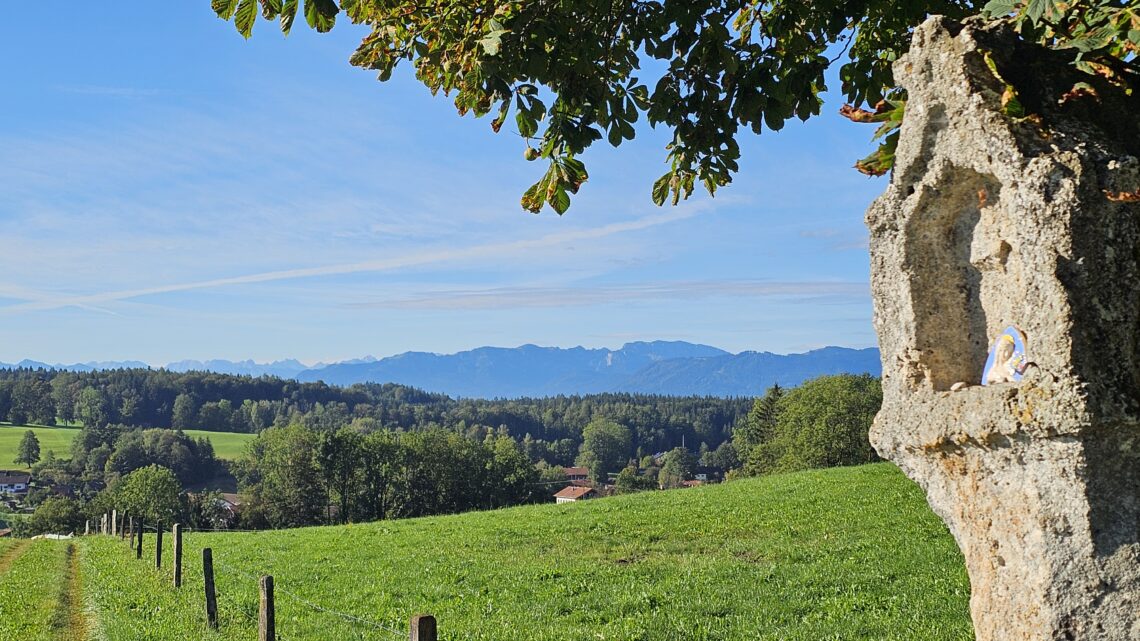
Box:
[0,368,751,465]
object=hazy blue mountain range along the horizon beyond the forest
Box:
[0,341,880,398]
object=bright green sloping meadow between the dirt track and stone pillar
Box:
[83,464,972,641]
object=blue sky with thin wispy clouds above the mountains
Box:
[0,0,886,365]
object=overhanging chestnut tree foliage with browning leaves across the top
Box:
[212,0,1140,213]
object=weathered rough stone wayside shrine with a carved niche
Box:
[866,17,1140,641]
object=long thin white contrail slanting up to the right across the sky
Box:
[0,208,698,314]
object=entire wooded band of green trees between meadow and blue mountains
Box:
[0,370,881,533]
